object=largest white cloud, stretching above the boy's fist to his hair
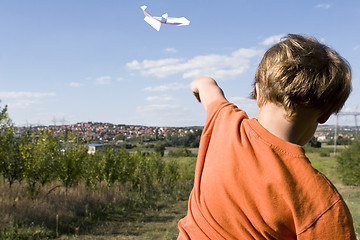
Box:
[126,48,263,79]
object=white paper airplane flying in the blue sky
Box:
[140,5,190,31]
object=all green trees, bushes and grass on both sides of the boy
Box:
[0,104,360,240]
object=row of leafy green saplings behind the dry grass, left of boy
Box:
[0,106,194,200]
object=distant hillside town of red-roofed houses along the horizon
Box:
[15,122,359,144]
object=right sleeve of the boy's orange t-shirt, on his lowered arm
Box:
[297,200,356,240]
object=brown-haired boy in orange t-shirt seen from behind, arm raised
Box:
[178,35,356,240]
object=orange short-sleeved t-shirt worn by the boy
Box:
[178,100,356,240]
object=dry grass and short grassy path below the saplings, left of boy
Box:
[0,157,196,240]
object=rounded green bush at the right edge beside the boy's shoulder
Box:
[337,138,360,186]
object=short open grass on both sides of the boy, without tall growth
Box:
[62,150,360,240]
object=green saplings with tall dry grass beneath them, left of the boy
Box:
[0,104,195,239]
